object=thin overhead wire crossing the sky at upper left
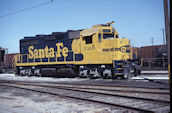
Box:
[0,0,53,18]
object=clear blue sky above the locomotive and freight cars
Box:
[0,0,165,53]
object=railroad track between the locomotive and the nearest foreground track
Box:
[0,80,170,95]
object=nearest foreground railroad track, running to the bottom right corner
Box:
[0,82,170,112]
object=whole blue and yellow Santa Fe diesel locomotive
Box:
[15,22,140,78]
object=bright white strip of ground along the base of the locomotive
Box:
[0,74,169,82]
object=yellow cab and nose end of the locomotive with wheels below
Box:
[73,22,141,78]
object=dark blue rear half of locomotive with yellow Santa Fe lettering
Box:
[15,31,79,77]
